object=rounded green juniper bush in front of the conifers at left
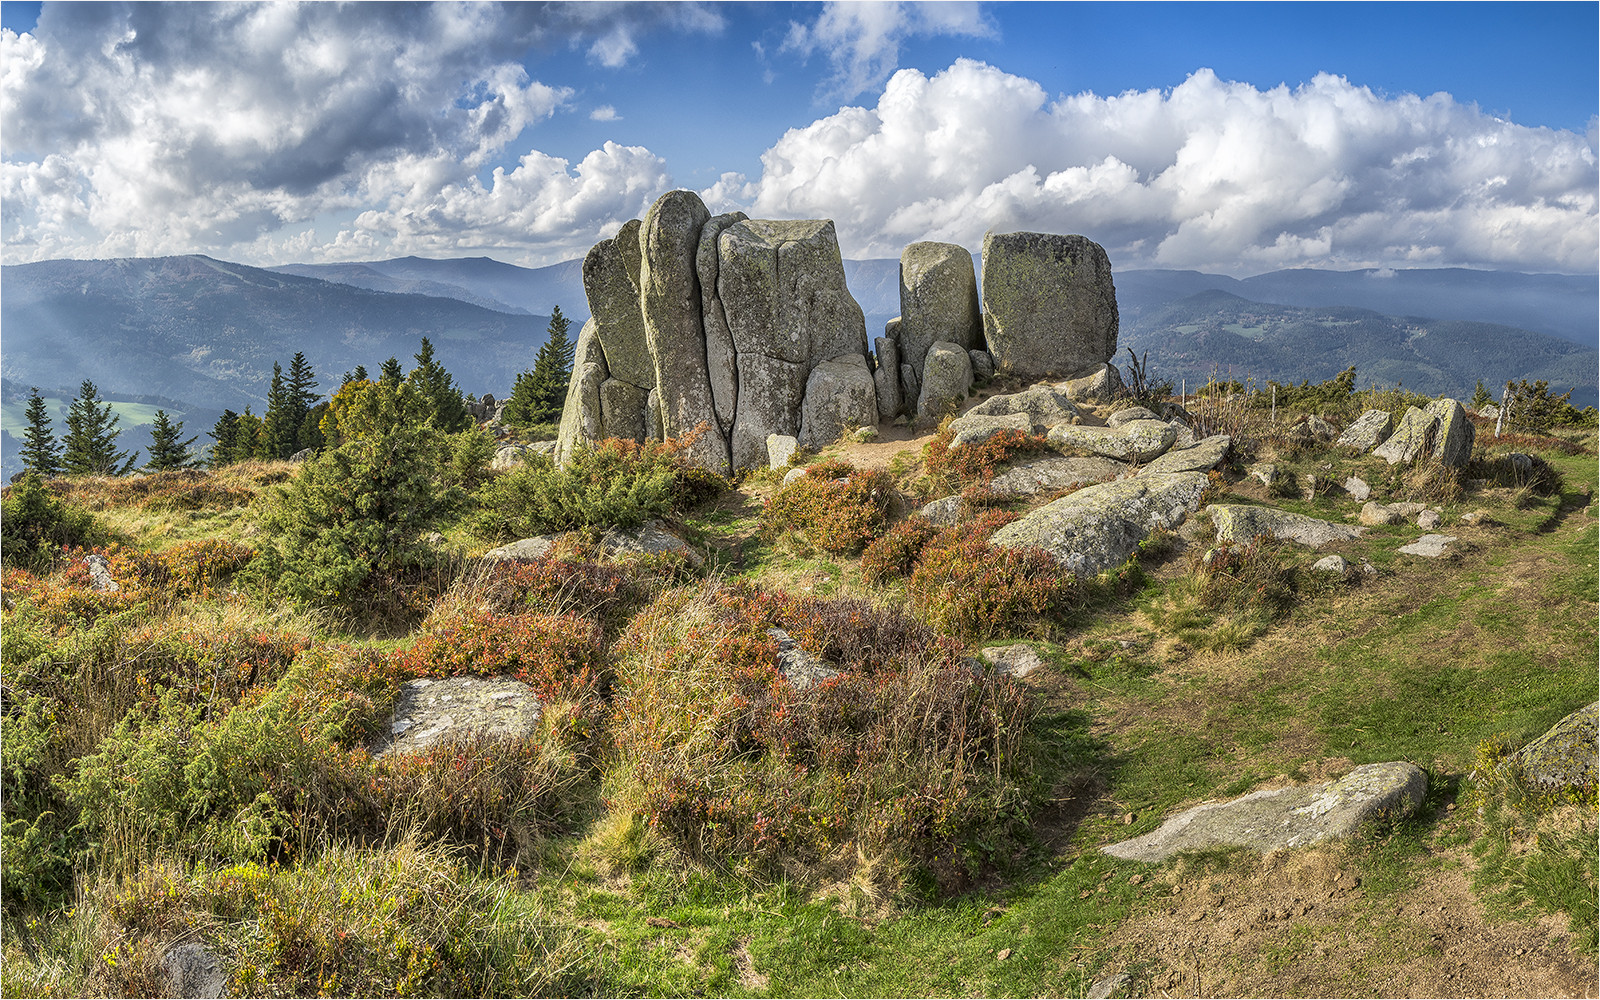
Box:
[246,427,462,608]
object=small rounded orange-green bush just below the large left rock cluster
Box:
[762,459,898,555]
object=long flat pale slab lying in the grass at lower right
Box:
[1101,762,1427,861]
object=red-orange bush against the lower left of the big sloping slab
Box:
[906,512,1078,643]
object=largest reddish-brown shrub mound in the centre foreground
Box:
[616,587,1034,883]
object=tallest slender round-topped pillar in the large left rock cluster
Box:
[638,190,730,475]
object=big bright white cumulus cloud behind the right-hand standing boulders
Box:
[729,59,1600,272]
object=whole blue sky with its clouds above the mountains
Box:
[0,3,1600,274]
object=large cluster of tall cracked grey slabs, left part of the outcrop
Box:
[557,190,876,475]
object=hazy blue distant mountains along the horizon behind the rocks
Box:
[0,256,1600,474]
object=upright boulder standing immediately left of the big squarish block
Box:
[899,243,984,401]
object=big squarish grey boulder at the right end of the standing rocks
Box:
[982,232,1117,379]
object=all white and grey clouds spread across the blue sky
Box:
[0,3,1600,274]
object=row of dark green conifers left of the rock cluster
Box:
[12,306,574,477]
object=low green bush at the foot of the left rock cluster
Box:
[472,438,726,539]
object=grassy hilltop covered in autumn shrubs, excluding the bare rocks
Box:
[0,368,1600,997]
